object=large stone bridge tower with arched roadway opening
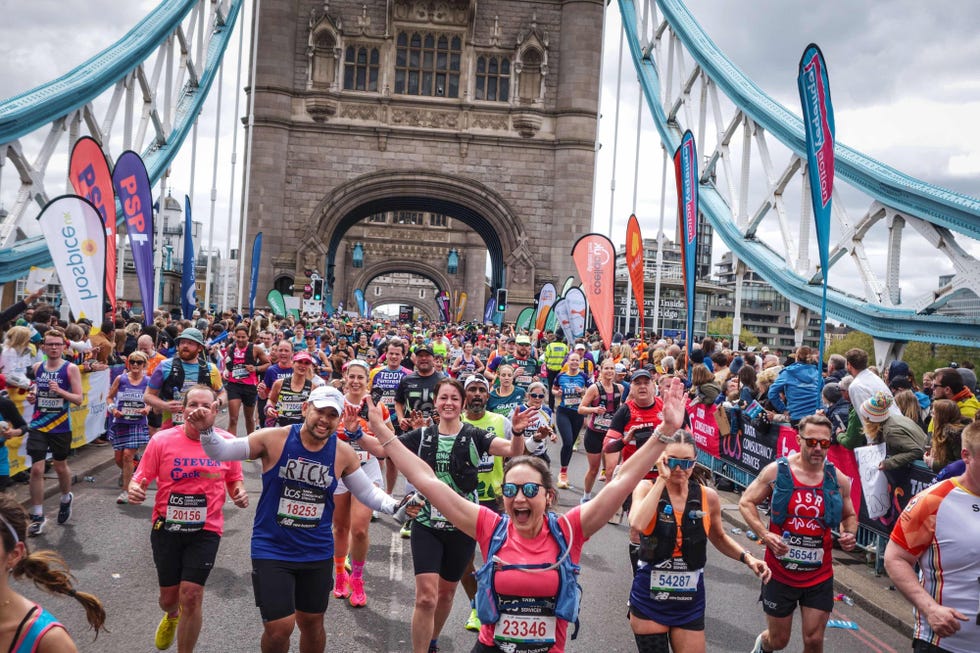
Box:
[246,0,604,319]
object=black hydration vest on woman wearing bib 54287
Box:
[640,479,708,571]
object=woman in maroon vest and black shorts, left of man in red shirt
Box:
[578,358,623,503]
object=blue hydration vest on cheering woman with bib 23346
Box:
[473,510,582,639]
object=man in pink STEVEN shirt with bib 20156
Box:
[129,385,248,653]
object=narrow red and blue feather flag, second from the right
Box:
[674,130,698,368]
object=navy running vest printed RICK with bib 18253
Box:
[252,424,337,562]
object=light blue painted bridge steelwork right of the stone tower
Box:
[619,0,980,346]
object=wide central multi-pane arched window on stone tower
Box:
[395,32,463,98]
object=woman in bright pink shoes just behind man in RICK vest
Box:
[333,358,390,608]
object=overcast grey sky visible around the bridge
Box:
[0,0,980,304]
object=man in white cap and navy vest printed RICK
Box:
[201,385,398,653]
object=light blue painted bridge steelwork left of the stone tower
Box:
[0,0,244,283]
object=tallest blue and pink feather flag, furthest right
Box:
[796,43,835,398]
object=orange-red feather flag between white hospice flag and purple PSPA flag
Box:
[68,136,116,312]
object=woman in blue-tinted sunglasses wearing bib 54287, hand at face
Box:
[629,431,771,653]
